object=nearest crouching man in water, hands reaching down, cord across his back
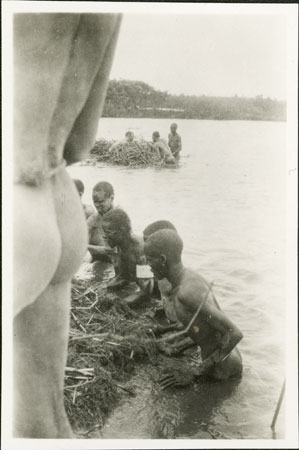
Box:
[145,230,243,388]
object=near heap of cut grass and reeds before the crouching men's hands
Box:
[64,282,161,432]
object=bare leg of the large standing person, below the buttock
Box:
[13,282,71,439]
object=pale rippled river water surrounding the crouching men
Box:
[68,119,286,439]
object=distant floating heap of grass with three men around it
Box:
[89,138,161,167]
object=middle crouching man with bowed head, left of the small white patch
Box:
[103,208,154,305]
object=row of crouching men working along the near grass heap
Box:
[74,180,243,387]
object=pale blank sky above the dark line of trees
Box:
[110,13,287,100]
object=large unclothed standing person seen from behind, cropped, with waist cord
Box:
[13,14,120,439]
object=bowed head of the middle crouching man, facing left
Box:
[103,208,131,248]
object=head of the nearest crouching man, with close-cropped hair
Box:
[144,230,183,280]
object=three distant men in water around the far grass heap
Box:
[109,123,182,164]
